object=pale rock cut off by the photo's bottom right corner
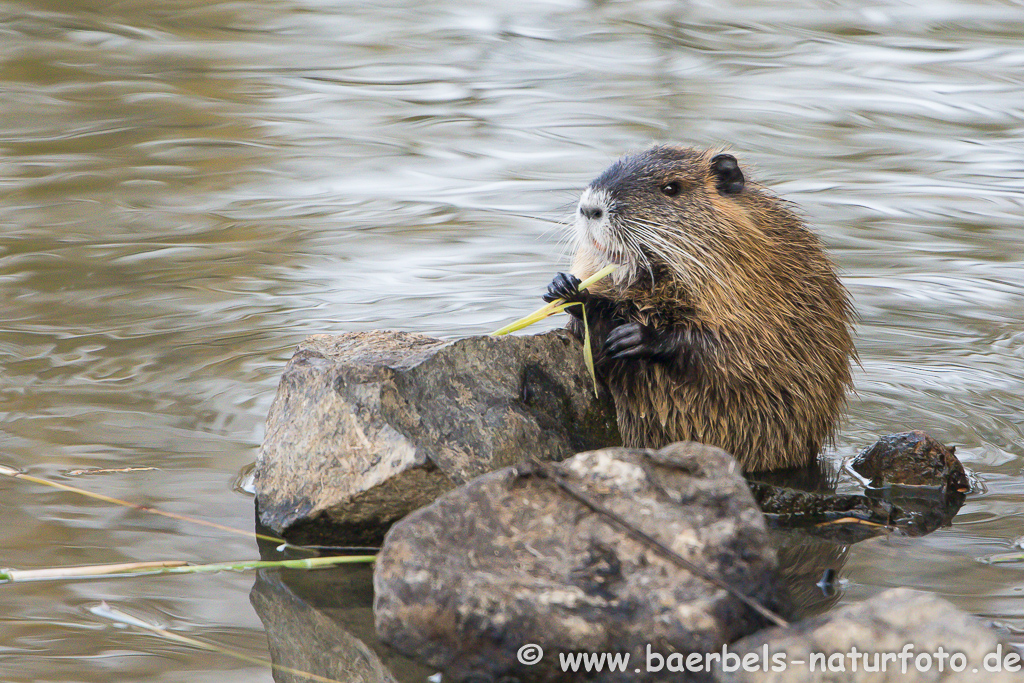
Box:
[717,588,1024,683]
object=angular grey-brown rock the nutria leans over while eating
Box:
[255,330,621,545]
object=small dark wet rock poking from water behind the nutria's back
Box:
[853,430,971,492]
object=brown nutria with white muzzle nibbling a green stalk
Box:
[544,146,856,471]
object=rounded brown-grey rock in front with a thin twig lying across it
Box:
[374,443,780,681]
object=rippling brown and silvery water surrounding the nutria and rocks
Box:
[0,0,1024,683]
